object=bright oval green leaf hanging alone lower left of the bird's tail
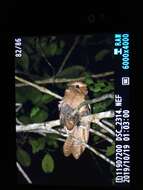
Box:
[42,153,54,173]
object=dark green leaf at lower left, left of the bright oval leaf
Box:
[16,147,31,167]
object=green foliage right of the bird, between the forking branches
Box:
[85,73,115,168]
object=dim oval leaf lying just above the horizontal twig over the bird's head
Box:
[57,65,85,78]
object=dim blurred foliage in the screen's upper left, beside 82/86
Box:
[15,36,66,77]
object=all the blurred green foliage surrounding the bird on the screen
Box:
[15,35,115,178]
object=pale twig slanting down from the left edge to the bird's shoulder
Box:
[15,76,62,100]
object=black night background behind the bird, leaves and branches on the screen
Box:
[17,33,115,186]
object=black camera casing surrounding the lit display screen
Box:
[1,1,142,189]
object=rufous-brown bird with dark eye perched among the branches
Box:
[59,82,90,159]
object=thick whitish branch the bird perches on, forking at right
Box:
[16,111,115,166]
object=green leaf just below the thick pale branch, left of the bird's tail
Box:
[29,137,45,154]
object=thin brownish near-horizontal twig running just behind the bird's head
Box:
[16,71,114,87]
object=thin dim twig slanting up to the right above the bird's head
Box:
[56,36,80,75]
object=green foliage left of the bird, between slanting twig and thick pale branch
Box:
[16,86,55,124]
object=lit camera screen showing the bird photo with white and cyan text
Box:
[13,32,131,187]
